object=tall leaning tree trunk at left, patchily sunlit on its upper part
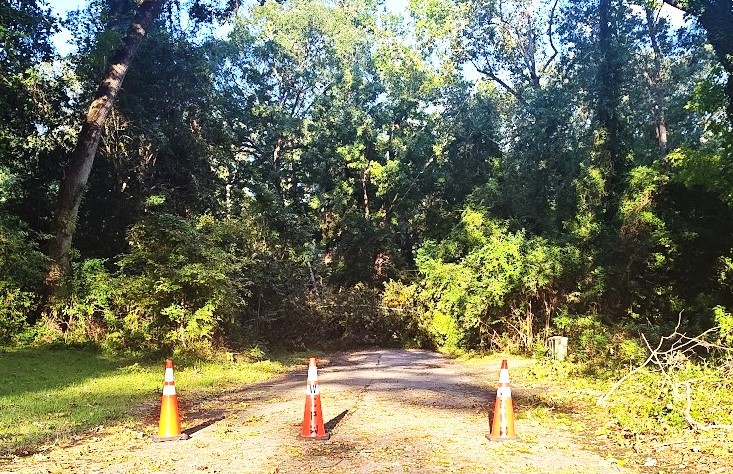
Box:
[46,0,165,297]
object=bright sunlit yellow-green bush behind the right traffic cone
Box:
[406,208,578,350]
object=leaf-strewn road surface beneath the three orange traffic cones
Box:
[0,350,632,474]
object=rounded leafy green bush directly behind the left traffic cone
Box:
[118,214,250,350]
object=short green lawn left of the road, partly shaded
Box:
[0,348,292,455]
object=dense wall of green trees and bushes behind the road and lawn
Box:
[0,0,733,351]
